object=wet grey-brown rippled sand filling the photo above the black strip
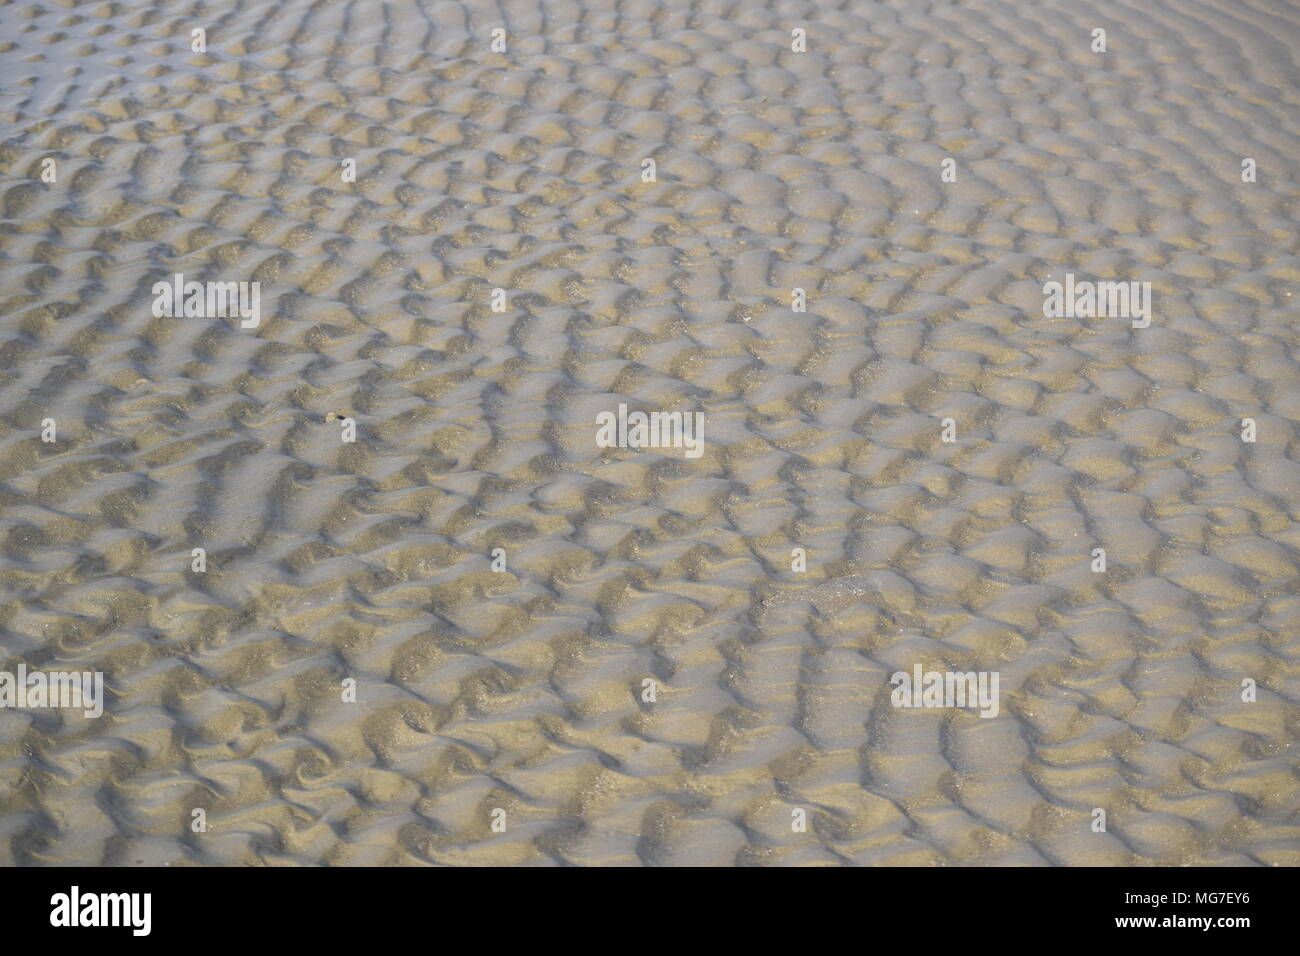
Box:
[0,0,1300,865]
